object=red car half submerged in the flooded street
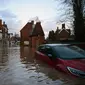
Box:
[35,44,85,78]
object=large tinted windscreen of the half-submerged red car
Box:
[54,46,85,59]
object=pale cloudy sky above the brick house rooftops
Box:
[0,0,67,36]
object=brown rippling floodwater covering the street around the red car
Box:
[0,46,85,85]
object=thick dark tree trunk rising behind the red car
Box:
[73,0,85,41]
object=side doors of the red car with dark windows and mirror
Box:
[36,45,54,66]
